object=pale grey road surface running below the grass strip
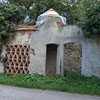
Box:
[0,85,100,100]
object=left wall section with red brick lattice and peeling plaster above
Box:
[0,31,32,74]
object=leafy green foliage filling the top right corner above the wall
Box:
[70,0,100,37]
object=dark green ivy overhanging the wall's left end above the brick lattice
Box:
[0,4,25,40]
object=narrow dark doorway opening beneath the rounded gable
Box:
[45,44,57,76]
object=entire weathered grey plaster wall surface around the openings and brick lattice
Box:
[0,14,100,77]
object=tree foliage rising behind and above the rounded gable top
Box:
[9,0,83,25]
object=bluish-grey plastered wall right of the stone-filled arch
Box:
[82,37,100,78]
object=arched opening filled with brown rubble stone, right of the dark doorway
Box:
[64,42,82,71]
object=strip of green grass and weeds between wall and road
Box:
[0,71,100,96]
